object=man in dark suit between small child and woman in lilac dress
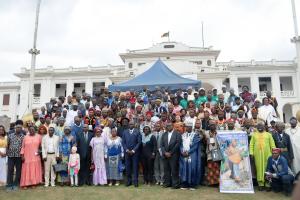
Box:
[76,124,93,185]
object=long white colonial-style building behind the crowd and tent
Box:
[0,42,300,121]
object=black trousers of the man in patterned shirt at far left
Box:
[7,157,22,187]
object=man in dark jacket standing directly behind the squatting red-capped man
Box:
[272,122,294,167]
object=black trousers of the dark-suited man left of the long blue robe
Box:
[163,155,179,188]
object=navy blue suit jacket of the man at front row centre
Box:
[122,129,142,154]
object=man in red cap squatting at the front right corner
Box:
[265,148,294,196]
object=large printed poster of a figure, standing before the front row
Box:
[217,131,254,193]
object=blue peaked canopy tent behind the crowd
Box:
[108,59,201,91]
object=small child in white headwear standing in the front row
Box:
[68,146,80,187]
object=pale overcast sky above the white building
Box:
[0,0,300,82]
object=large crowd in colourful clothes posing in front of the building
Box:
[0,86,300,195]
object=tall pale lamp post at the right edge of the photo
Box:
[291,0,300,102]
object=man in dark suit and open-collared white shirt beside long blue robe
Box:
[160,122,181,189]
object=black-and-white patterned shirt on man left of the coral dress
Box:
[7,133,24,157]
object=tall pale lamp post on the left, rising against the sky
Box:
[28,0,41,113]
